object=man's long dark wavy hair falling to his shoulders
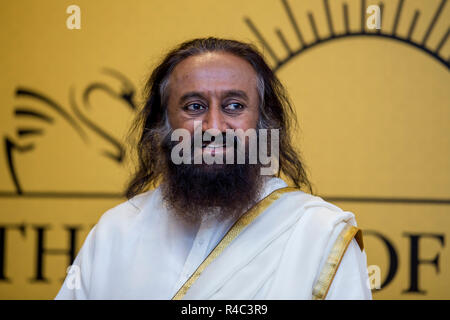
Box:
[125,37,313,199]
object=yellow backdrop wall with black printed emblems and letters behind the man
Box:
[0,0,450,299]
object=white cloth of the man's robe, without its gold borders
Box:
[56,178,371,299]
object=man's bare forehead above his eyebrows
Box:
[169,52,256,94]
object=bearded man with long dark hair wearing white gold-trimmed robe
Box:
[56,38,371,299]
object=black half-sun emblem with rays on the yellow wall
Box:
[243,0,450,204]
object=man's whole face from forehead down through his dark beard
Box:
[161,53,262,222]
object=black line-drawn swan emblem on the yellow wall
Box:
[3,68,136,196]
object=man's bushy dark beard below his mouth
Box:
[160,143,265,224]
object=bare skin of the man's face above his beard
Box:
[168,52,259,153]
